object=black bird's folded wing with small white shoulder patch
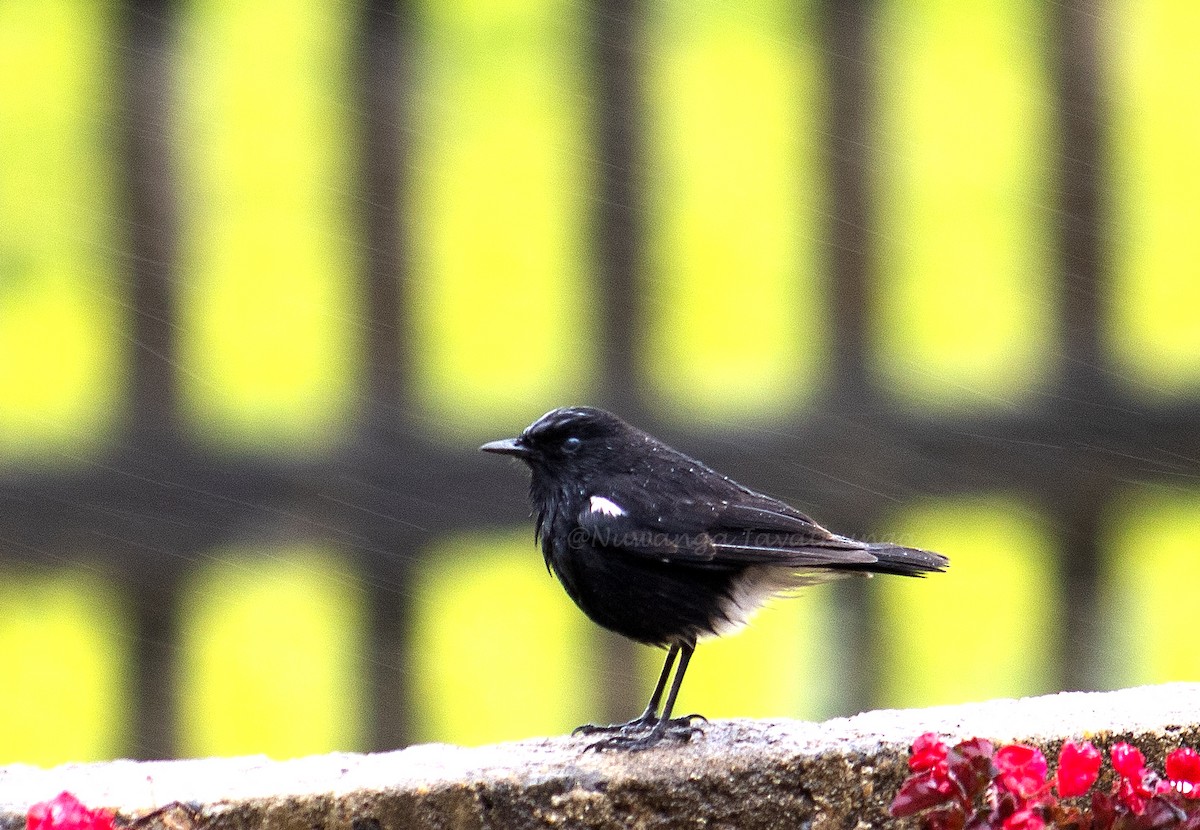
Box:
[577,488,877,569]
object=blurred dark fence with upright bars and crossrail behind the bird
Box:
[0,0,1200,757]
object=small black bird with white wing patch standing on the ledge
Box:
[480,407,949,750]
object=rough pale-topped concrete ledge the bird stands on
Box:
[0,684,1200,830]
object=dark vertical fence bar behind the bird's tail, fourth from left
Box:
[816,0,877,712]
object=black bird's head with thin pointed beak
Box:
[479,407,636,483]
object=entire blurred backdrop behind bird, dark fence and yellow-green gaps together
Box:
[0,0,1200,760]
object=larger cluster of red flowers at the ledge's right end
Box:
[892,733,1200,830]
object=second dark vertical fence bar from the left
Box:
[356,0,413,750]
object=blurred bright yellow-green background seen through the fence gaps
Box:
[0,0,1200,764]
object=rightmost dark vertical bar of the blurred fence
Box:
[1046,0,1108,688]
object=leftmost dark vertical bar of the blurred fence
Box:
[118,0,180,758]
